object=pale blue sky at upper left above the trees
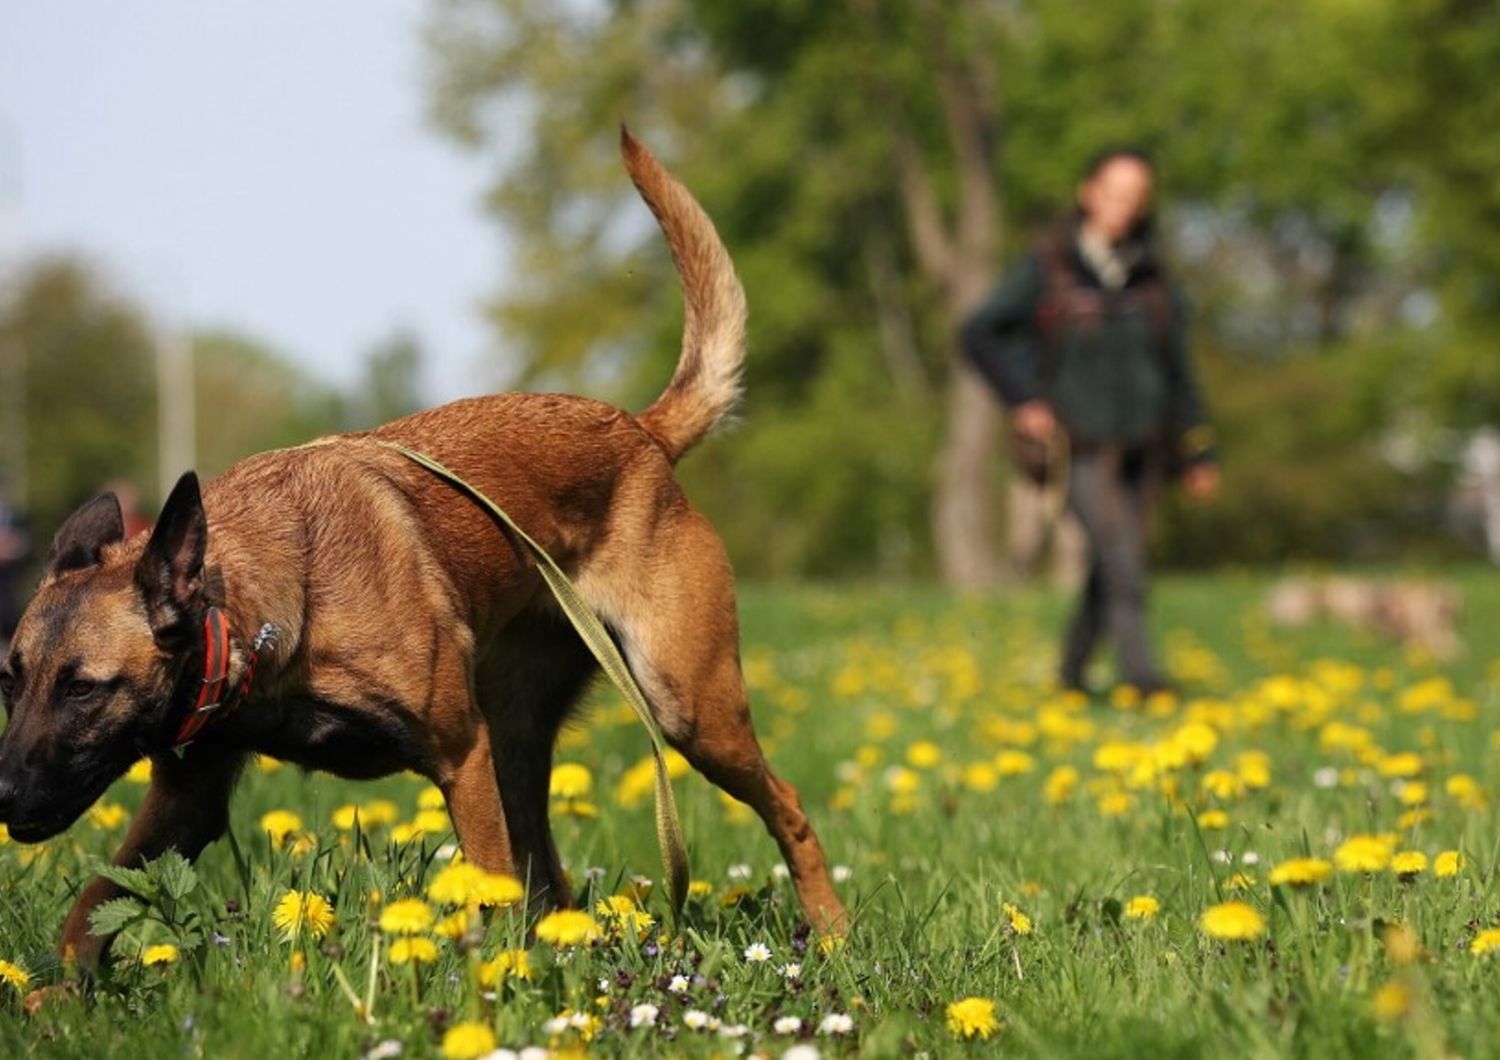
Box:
[0,0,506,400]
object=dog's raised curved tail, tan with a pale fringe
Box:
[620,126,746,463]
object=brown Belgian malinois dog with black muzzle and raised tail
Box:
[0,130,846,969]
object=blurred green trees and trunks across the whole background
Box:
[0,0,1500,585]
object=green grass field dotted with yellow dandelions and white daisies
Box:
[0,571,1500,1060]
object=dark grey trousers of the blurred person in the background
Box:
[1059,445,1166,691]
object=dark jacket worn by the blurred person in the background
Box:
[962,229,1214,465]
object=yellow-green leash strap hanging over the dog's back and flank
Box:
[380,441,689,916]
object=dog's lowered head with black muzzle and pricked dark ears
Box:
[0,472,209,843]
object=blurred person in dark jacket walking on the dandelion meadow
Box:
[963,148,1220,694]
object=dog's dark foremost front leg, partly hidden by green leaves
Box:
[59,745,245,972]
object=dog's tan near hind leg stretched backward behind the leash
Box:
[581,502,848,933]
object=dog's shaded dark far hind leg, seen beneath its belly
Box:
[477,614,599,909]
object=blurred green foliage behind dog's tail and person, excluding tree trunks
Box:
[428,0,1500,576]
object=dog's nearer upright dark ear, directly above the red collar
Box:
[135,471,209,646]
